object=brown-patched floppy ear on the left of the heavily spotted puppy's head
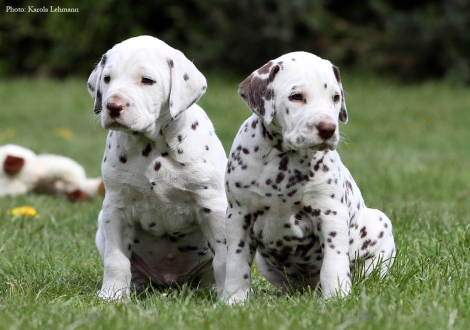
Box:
[238,61,280,125]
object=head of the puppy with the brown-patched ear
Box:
[238,52,348,150]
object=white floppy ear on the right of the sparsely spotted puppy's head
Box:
[168,49,207,119]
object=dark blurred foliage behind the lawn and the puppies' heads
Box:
[0,0,470,84]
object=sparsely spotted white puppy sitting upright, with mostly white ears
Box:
[88,36,227,299]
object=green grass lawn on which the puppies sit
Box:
[0,73,470,330]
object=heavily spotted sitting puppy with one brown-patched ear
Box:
[224,52,395,304]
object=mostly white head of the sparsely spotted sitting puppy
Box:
[88,36,207,133]
